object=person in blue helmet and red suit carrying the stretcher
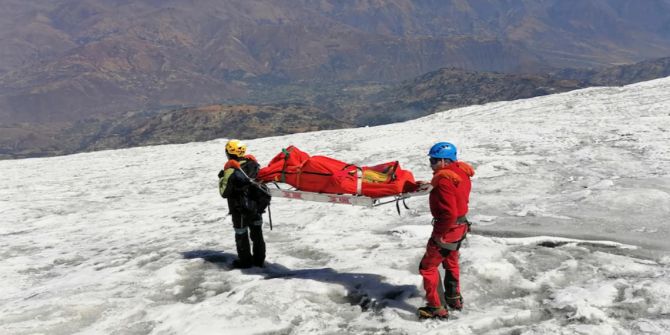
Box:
[418,142,474,318]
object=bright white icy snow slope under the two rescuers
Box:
[0,78,670,334]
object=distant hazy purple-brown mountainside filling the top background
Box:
[0,0,670,125]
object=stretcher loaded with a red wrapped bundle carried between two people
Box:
[257,146,432,211]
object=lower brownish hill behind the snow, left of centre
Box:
[0,104,353,158]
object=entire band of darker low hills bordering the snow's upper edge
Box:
[5,58,670,158]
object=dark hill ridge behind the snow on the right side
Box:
[353,57,670,125]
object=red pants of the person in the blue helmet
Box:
[419,239,461,307]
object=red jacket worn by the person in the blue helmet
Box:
[428,161,475,242]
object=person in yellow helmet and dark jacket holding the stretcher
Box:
[219,140,265,268]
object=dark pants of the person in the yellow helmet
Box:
[232,213,265,266]
